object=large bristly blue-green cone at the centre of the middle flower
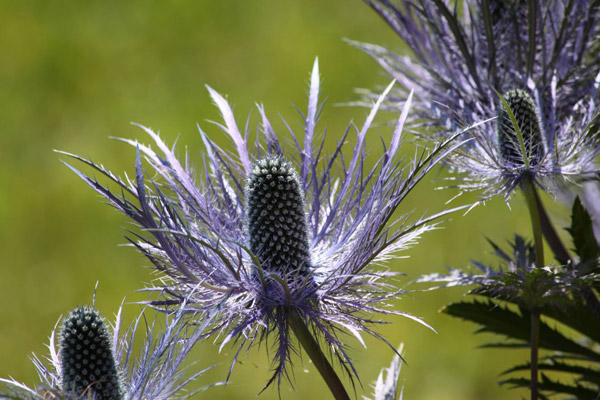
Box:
[246,156,311,279]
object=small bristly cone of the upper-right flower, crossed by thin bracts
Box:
[498,89,544,166]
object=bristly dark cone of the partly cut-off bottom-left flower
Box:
[59,306,123,400]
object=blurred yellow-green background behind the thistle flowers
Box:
[0,0,566,400]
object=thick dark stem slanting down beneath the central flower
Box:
[289,311,350,400]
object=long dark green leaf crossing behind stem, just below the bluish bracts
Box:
[442,301,600,360]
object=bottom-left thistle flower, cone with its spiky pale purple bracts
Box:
[0,302,219,400]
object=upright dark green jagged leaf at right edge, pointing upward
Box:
[567,197,600,264]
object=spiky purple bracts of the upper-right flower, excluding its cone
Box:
[353,0,600,199]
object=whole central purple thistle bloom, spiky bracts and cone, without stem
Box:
[57,62,468,386]
